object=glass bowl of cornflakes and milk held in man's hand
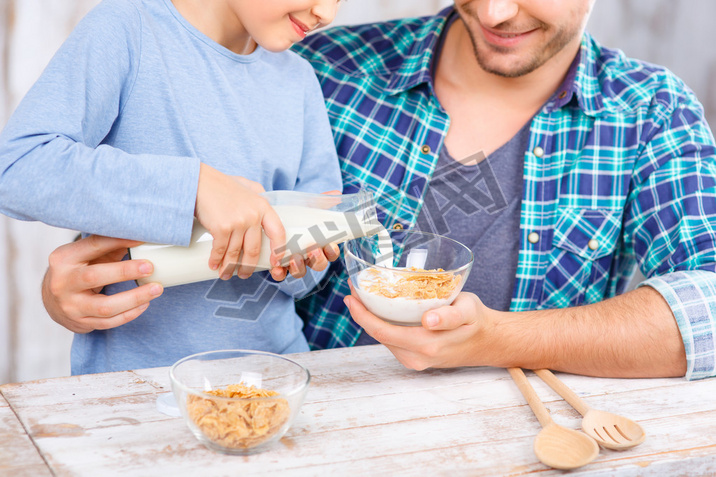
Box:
[344,230,473,326]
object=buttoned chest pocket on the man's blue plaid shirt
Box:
[540,207,621,308]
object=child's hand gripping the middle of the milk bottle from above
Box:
[195,163,286,280]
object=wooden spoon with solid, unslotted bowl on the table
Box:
[507,368,599,470]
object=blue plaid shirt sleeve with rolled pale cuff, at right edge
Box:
[626,80,716,379]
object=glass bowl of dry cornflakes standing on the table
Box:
[169,350,311,454]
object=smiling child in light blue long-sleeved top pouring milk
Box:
[0,0,342,374]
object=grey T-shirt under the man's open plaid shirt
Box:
[416,122,530,311]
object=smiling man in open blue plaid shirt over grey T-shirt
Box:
[39,0,716,379]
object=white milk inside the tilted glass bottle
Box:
[130,205,386,287]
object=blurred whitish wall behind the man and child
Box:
[0,0,716,384]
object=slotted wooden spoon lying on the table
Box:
[535,369,646,450]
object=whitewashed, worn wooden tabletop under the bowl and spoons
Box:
[0,345,716,476]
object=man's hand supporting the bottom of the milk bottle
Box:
[42,235,163,333]
